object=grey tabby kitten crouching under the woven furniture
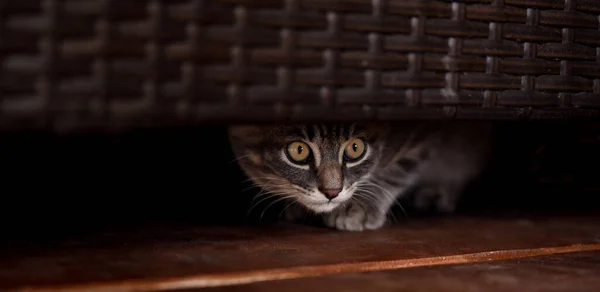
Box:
[229,121,492,231]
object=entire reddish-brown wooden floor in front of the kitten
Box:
[0,215,600,292]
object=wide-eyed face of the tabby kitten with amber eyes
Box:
[230,125,386,213]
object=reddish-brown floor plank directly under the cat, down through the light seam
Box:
[0,216,600,291]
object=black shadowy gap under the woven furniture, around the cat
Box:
[0,122,600,244]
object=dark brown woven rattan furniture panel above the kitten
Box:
[0,0,600,129]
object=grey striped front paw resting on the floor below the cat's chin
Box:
[323,202,386,231]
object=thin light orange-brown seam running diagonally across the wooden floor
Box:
[7,243,600,292]
